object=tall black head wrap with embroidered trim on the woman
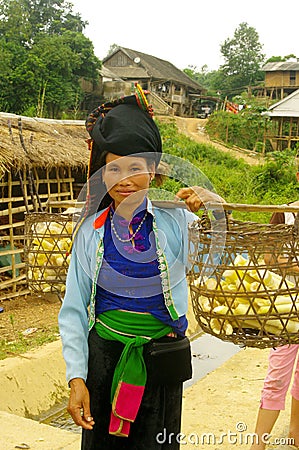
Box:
[76,84,162,225]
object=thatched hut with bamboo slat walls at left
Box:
[0,113,89,300]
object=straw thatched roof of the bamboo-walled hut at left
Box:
[0,113,89,172]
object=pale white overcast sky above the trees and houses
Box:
[70,0,299,70]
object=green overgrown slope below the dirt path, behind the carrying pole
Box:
[158,118,299,223]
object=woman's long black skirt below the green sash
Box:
[81,328,182,450]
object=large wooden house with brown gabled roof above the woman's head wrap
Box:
[102,47,205,117]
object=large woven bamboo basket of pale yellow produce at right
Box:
[189,209,299,348]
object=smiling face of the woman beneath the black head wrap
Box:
[103,153,154,209]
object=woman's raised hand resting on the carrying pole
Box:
[176,186,225,212]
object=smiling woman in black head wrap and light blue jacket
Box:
[59,87,221,450]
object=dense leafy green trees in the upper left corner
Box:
[0,0,100,117]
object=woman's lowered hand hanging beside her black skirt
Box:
[67,378,94,430]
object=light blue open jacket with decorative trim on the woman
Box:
[58,201,198,381]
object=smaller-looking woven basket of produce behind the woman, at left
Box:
[24,212,73,295]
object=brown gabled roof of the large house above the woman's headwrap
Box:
[103,47,204,91]
